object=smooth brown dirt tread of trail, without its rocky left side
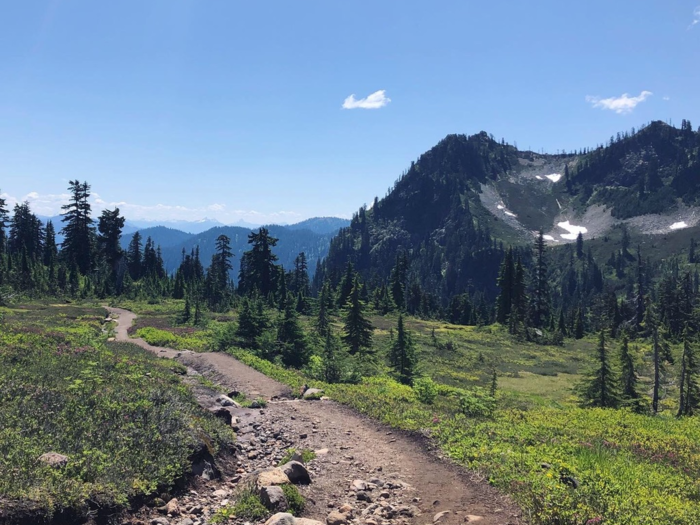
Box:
[107,308,522,525]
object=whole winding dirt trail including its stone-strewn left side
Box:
[108,308,522,525]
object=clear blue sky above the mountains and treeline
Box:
[0,0,700,223]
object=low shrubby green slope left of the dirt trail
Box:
[0,304,233,514]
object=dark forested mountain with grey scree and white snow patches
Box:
[316,121,700,303]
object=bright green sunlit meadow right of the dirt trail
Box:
[106,302,700,525]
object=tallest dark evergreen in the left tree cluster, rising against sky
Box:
[61,180,95,275]
